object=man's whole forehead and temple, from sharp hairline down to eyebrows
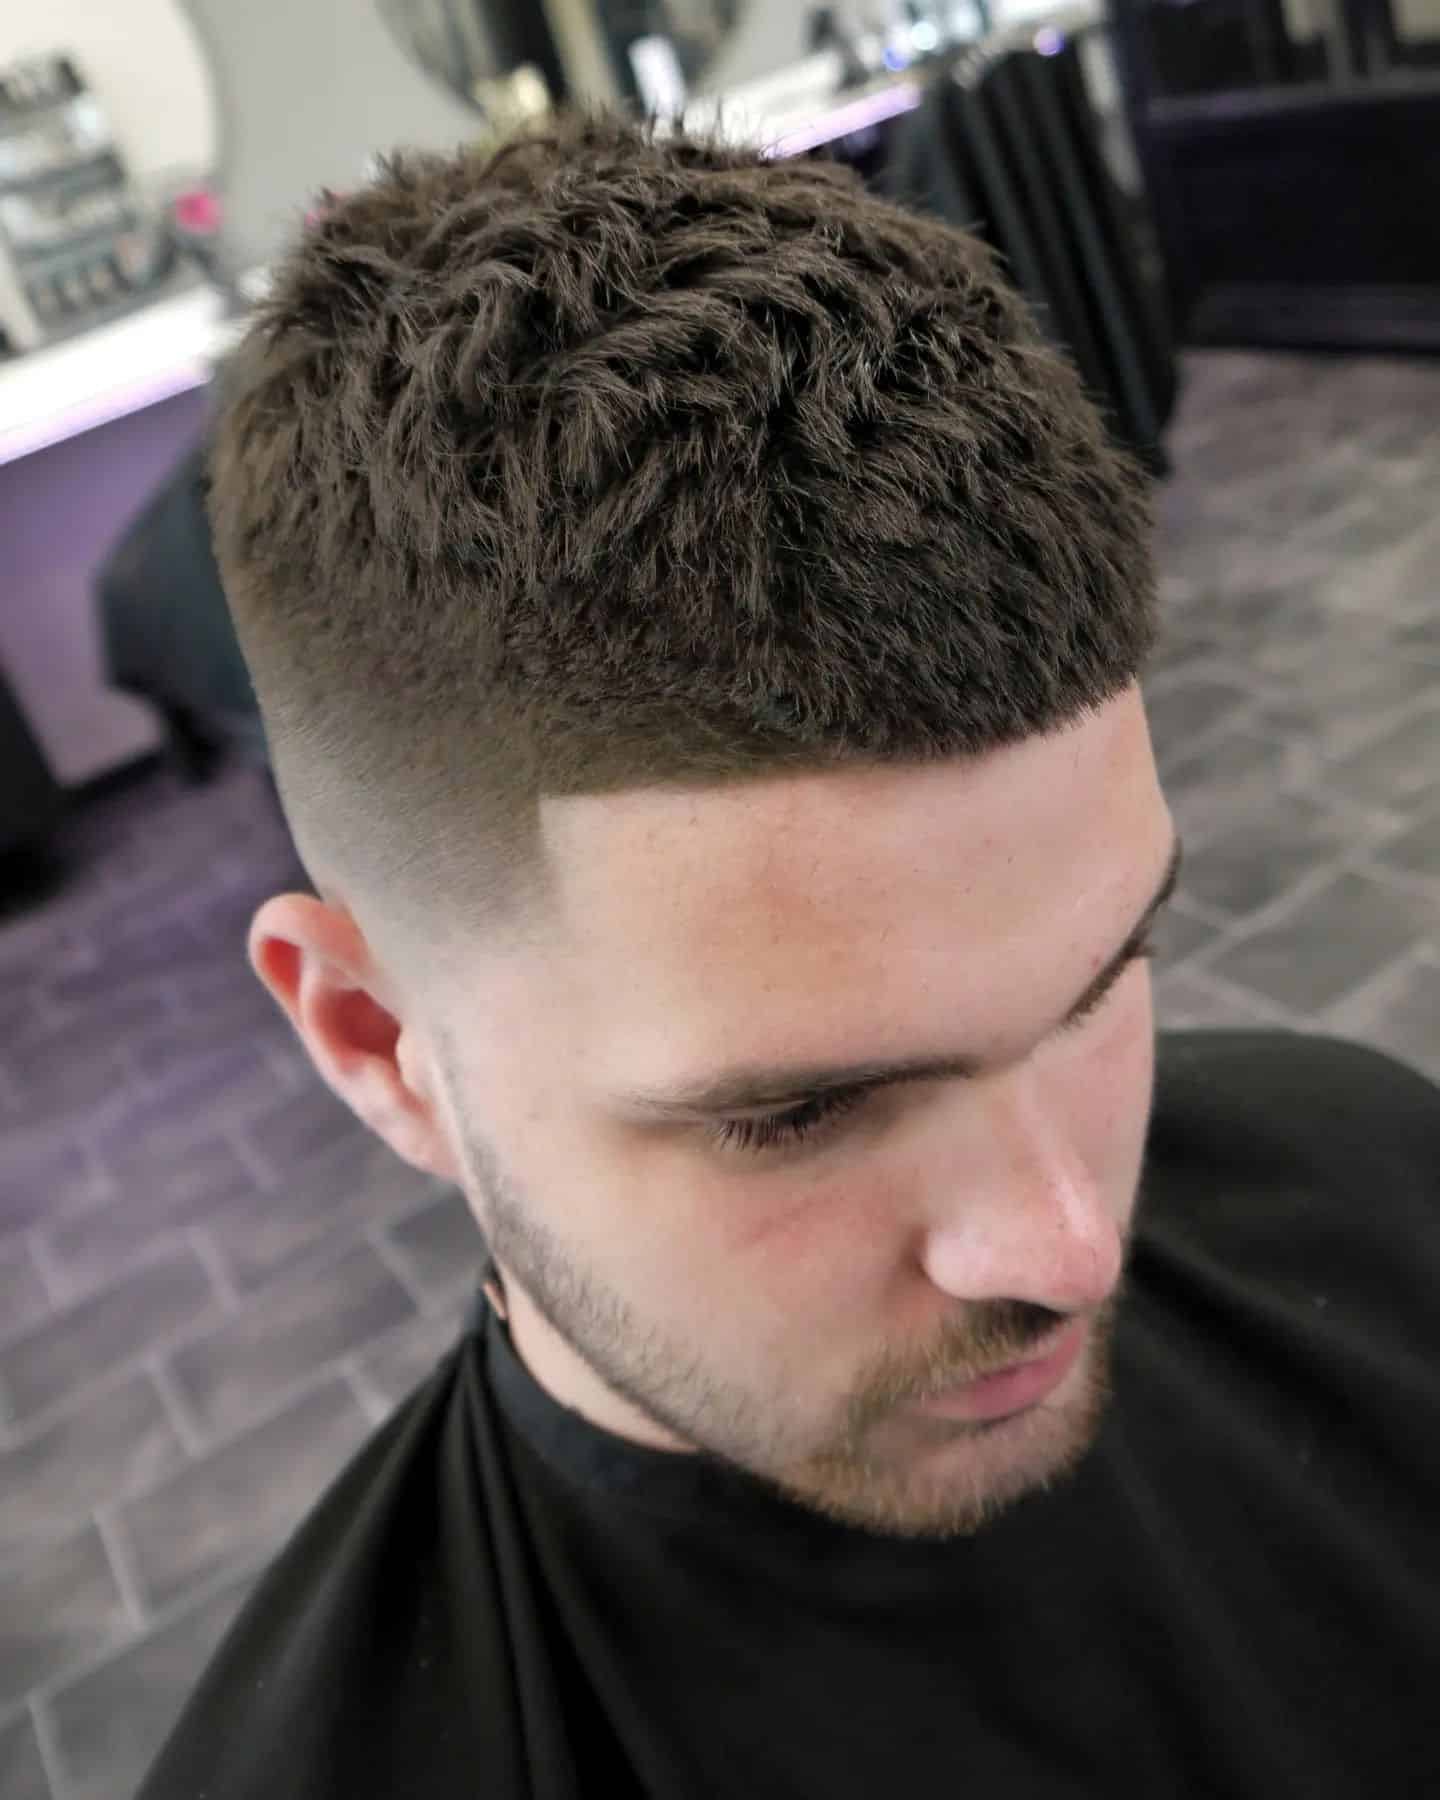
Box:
[455,691,1172,1096]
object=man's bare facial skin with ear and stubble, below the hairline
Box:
[248,686,1175,1535]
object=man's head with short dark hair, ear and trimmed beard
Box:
[212,119,1172,1532]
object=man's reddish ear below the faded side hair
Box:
[247,895,459,1184]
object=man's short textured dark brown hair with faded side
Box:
[209,112,1156,986]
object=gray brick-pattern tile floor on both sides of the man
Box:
[0,343,1440,1800]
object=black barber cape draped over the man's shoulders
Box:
[140,1031,1440,1800]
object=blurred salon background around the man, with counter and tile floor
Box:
[0,0,1440,1800]
